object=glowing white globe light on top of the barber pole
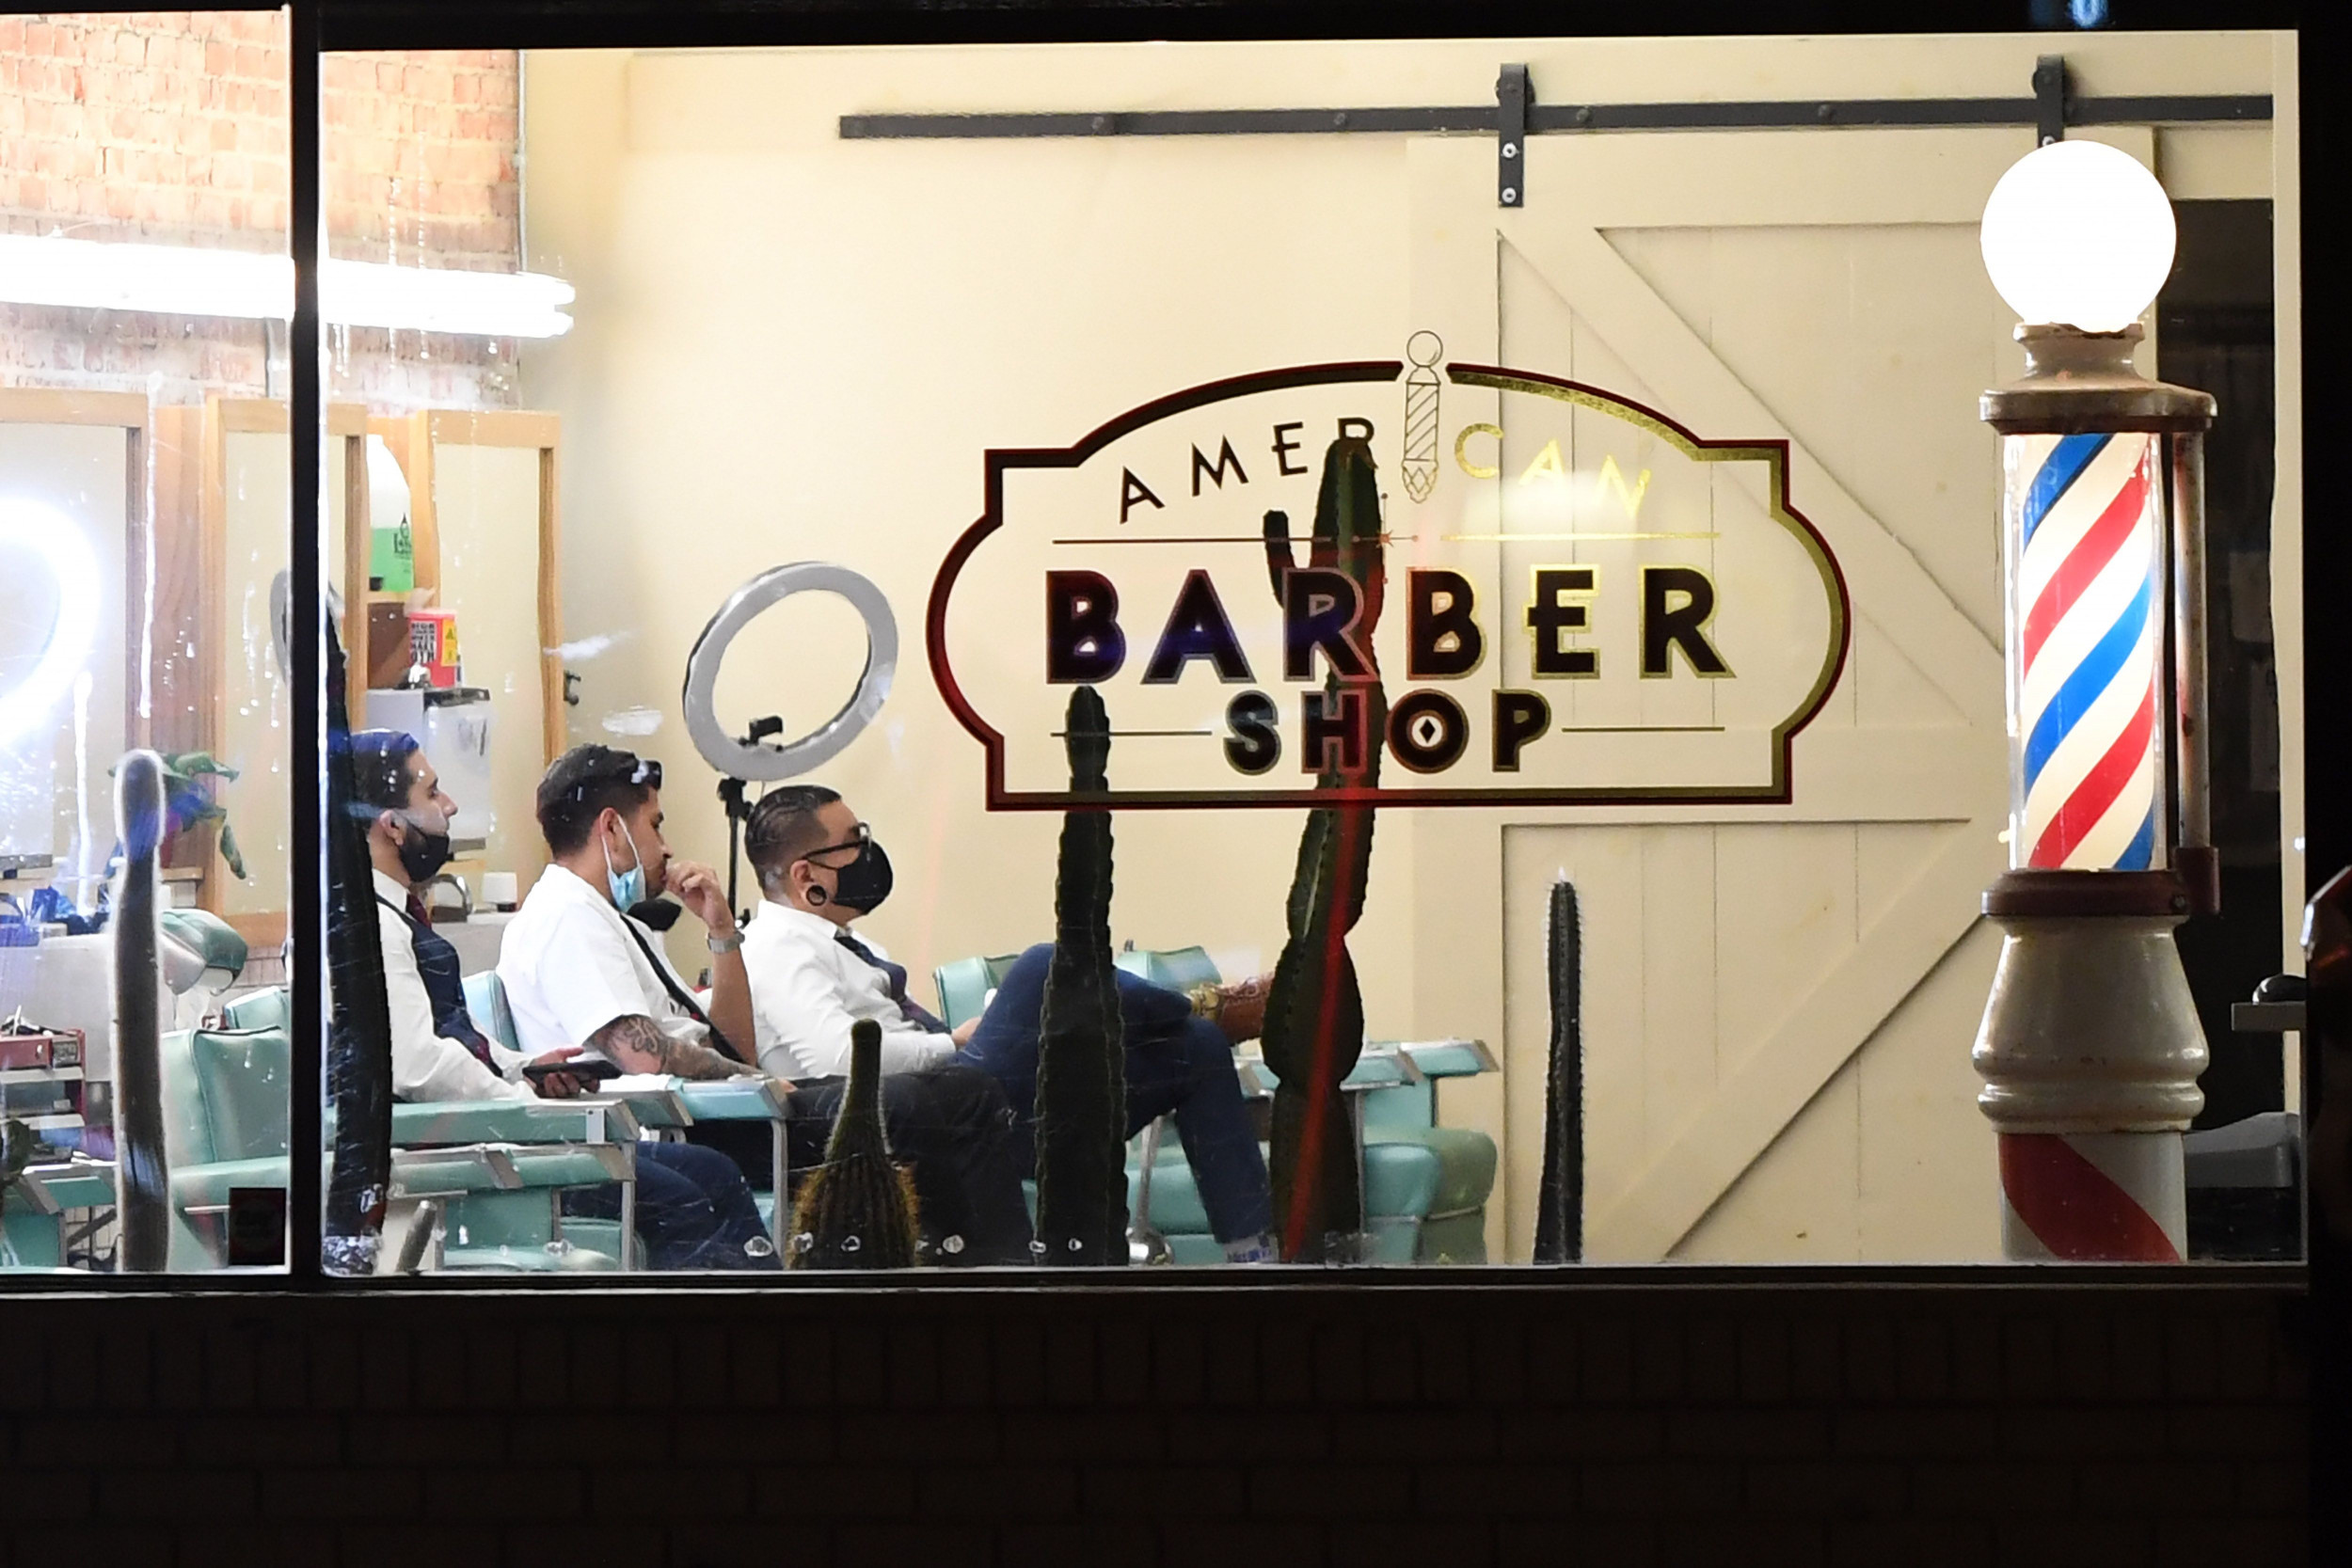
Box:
[1980,141,2173,331]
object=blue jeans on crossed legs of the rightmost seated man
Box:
[964,942,1273,1242]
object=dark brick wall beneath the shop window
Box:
[0,1281,2308,1568]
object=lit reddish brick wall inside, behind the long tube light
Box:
[0,11,522,411]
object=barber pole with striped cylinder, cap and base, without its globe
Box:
[1976,326,2218,1262]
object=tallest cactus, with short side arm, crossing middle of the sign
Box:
[1263,435,1388,1262]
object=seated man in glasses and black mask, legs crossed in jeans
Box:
[743,785,1275,1262]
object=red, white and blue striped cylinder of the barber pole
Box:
[2004,435,2164,872]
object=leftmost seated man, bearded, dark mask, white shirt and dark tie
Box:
[351,729,781,1270]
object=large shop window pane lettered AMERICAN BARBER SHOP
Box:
[308,38,2300,1275]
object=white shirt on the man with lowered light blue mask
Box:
[499,865,708,1055]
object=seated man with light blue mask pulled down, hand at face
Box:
[499,745,1030,1265]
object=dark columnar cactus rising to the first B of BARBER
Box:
[1038,687,1127,1267]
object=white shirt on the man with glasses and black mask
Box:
[739,900,955,1079]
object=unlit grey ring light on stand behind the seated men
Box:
[685,562,898,783]
